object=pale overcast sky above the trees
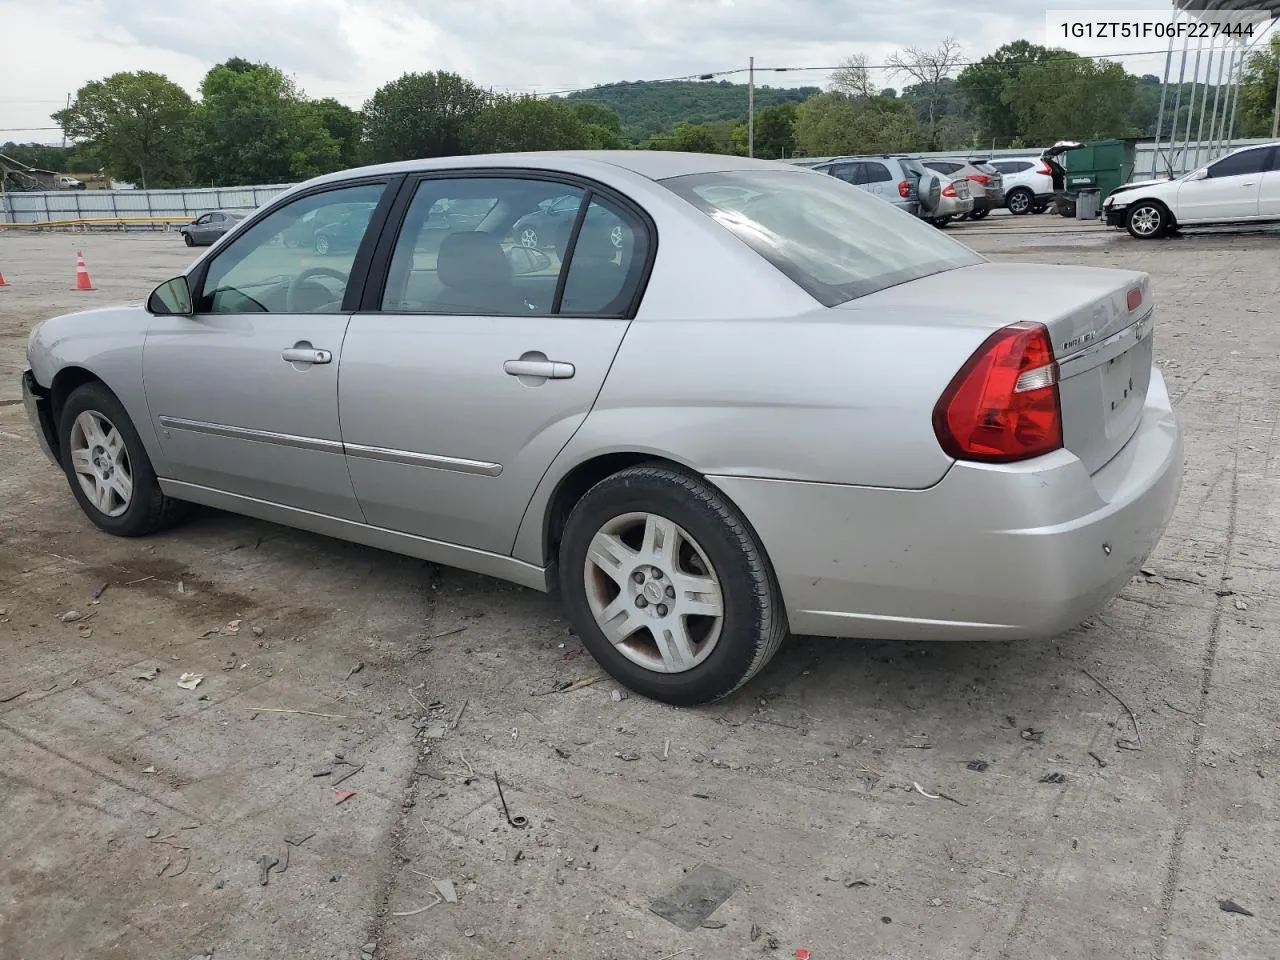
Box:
[0,0,1269,143]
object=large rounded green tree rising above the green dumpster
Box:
[1001,51,1138,143]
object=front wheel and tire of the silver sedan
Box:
[58,381,188,536]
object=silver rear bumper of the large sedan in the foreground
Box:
[713,370,1183,640]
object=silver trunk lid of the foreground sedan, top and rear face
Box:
[838,262,1153,474]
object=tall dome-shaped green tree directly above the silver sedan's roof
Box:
[364,70,489,163]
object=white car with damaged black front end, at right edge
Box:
[1102,142,1280,239]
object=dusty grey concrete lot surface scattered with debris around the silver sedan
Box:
[0,218,1280,960]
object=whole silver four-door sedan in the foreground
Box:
[22,151,1183,704]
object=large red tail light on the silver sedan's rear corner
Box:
[933,323,1062,463]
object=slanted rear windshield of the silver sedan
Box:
[662,170,983,307]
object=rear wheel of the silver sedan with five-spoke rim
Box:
[558,463,787,707]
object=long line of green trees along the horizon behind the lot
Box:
[12,37,1280,187]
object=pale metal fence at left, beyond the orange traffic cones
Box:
[0,184,292,228]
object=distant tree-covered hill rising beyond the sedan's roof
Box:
[566,81,822,141]
